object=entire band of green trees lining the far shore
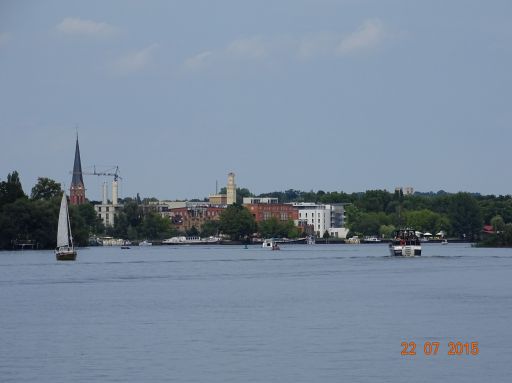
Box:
[0,171,512,249]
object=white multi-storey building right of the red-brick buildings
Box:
[293,202,348,238]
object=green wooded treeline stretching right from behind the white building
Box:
[260,190,512,245]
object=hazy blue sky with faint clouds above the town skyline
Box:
[0,0,512,200]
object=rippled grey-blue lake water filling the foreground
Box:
[0,244,512,383]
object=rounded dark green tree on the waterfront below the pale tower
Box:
[219,204,256,241]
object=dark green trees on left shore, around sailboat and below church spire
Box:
[0,171,176,250]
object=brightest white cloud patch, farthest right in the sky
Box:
[337,19,387,55]
